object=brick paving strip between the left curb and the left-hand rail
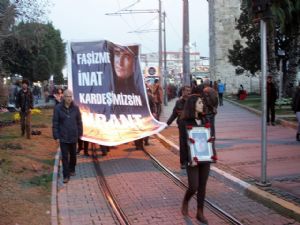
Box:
[57,156,118,225]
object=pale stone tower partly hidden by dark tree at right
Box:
[208,0,258,93]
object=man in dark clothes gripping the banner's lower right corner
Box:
[167,85,191,169]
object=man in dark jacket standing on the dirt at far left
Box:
[16,80,33,139]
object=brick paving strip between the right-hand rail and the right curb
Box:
[147,139,300,225]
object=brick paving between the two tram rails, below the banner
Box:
[96,143,230,225]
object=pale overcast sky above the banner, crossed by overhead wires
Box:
[49,0,209,56]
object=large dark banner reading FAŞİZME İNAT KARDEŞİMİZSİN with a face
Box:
[68,40,166,146]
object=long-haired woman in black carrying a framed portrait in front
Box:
[179,95,210,224]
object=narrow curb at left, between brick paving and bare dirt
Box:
[51,148,60,225]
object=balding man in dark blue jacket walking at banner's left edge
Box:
[52,90,82,183]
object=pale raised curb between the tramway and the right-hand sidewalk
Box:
[156,134,300,221]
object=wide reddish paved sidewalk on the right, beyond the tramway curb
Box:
[161,99,300,218]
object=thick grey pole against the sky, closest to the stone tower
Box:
[182,0,191,85]
